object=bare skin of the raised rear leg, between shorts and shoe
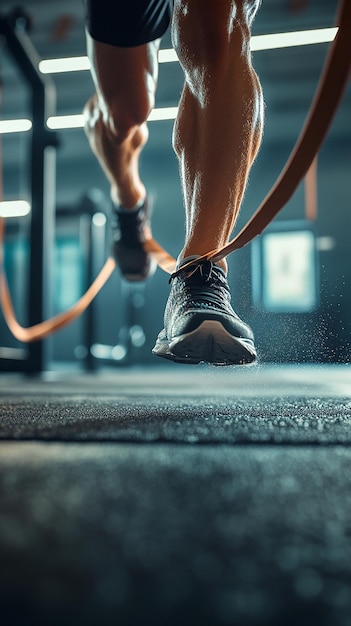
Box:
[84,35,159,209]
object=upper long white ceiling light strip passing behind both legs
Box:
[39,28,338,74]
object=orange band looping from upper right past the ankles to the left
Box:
[0,0,351,342]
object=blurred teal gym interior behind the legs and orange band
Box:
[0,0,351,370]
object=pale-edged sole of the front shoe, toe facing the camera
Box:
[152,320,257,365]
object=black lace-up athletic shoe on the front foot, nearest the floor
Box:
[153,261,256,365]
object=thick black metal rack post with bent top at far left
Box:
[0,12,57,374]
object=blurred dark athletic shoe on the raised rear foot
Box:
[112,200,156,281]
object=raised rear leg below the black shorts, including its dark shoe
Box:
[85,35,159,281]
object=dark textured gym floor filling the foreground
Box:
[0,363,351,626]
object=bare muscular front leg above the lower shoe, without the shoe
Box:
[172,0,263,270]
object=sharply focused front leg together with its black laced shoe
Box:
[153,0,263,365]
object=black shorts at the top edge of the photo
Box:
[84,0,173,47]
